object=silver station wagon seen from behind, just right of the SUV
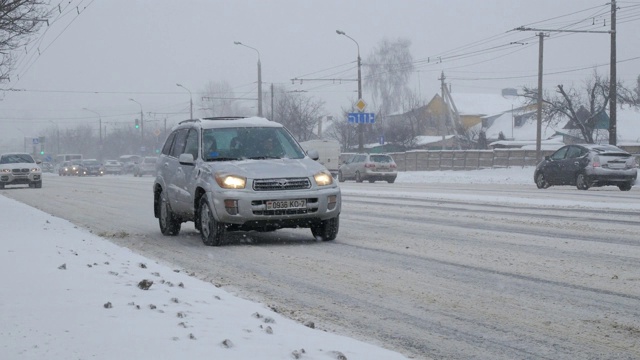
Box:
[338,154,398,184]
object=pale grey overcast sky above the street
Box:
[0,0,640,150]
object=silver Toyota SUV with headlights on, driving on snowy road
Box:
[153,117,341,246]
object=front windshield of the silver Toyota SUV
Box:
[202,127,304,161]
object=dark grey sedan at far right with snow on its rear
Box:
[533,144,638,191]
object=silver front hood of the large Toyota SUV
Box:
[207,158,326,179]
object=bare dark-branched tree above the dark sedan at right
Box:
[523,71,637,144]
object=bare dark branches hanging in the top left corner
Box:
[0,0,50,82]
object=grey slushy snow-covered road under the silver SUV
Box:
[6,171,640,359]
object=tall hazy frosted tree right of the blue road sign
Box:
[364,39,413,115]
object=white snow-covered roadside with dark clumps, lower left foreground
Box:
[0,194,406,360]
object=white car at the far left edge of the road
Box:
[0,153,42,189]
